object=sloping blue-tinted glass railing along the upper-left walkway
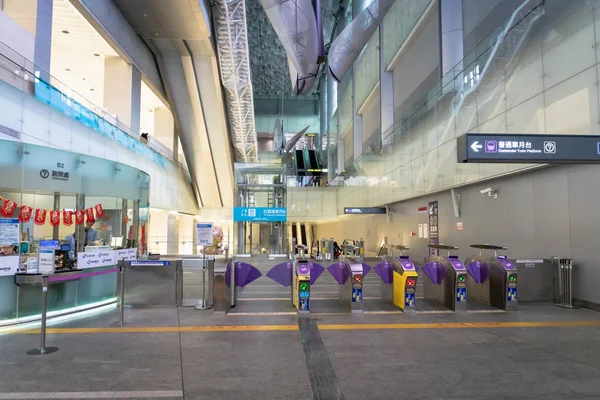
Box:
[0,41,187,170]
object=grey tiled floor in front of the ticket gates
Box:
[0,304,600,400]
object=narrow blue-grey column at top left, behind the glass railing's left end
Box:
[33,0,53,82]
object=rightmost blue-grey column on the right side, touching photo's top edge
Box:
[438,0,464,76]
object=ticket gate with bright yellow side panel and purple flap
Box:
[374,245,418,313]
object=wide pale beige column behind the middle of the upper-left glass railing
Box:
[103,56,142,133]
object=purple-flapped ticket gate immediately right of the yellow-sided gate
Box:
[421,244,467,311]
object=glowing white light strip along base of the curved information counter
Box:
[0,297,117,333]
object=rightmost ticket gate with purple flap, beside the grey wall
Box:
[465,244,518,310]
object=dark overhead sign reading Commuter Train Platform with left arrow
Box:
[457,133,600,164]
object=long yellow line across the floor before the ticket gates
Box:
[6,320,600,334]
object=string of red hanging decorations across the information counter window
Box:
[0,196,110,226]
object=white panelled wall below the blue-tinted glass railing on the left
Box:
[0,81,198,214]
